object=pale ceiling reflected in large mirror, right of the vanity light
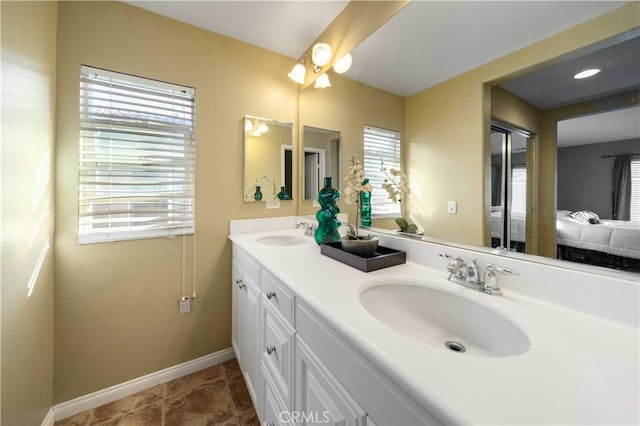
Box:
[347,1,624,96]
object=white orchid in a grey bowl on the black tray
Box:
[341,154,378,257]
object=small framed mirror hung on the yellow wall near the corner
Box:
[242,115,293,202]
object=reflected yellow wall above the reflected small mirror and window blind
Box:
[298,73,404,221]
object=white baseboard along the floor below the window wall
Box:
[51,348,235,426]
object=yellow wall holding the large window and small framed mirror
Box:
[55,2,298,402]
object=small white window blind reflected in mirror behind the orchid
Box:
[363,126,400,217]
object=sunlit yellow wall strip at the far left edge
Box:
[0,2,57,425]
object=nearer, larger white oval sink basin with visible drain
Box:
[360,281,529,357]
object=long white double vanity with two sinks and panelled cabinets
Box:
[229,217,640,426]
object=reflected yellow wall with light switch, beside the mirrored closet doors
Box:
[404,2,640,245]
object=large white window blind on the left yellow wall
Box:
[78,66,195,244]
